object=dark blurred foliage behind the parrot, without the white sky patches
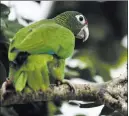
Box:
[0,1,128,116]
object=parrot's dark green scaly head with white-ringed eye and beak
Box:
[54,11,89,42]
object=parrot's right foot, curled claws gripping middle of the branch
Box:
[56,80,76,93]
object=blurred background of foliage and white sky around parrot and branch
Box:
[0,1,128,116]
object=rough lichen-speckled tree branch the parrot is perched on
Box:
[0,73,128,115]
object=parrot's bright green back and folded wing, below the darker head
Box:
[9,20,75,61]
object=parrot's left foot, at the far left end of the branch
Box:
[1,79,15,100]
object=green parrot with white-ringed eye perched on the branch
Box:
[2,11,89,93]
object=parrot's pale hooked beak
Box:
[76,25,89,42]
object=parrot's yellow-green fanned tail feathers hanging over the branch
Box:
[9,54,53,92]
